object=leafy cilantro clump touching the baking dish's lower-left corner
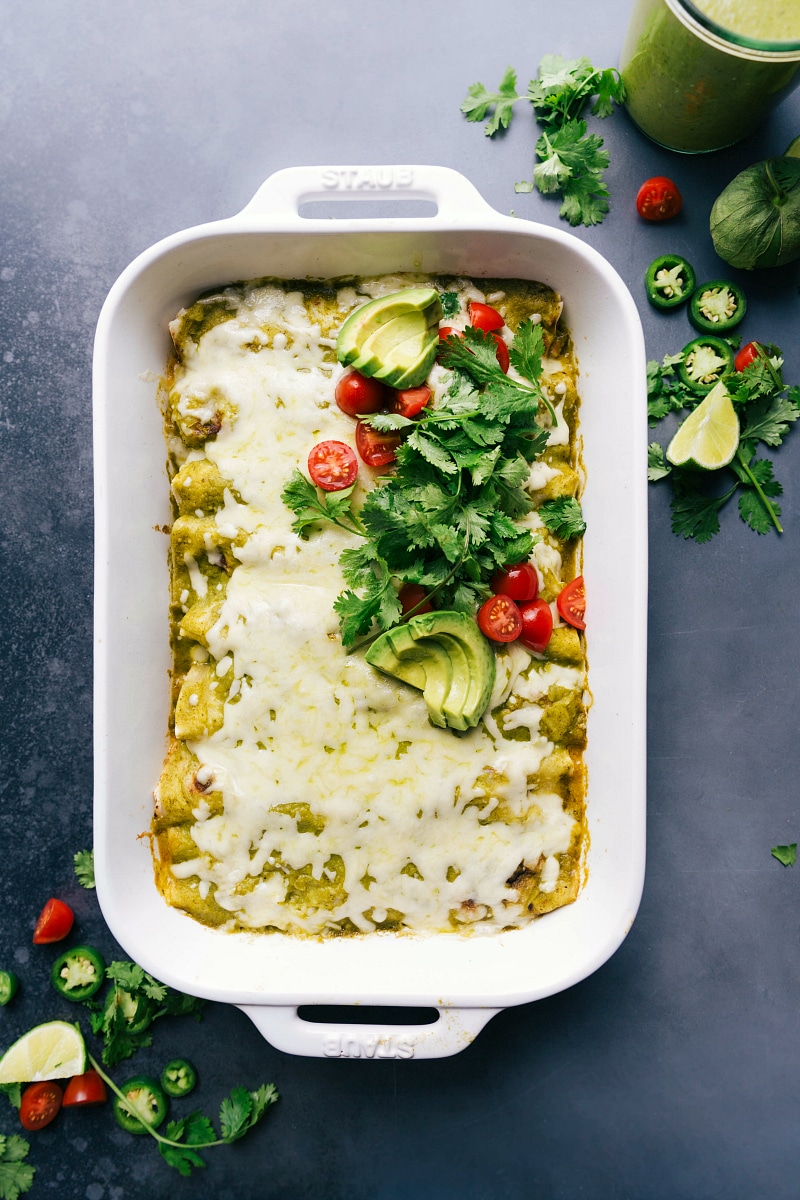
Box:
[84,962,204,1067]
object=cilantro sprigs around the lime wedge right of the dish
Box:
[648,344,800,542]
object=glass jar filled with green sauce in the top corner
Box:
[620,0,800,154]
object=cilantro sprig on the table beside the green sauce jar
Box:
[461,54,625,226]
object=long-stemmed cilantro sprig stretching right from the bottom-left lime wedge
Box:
[88,1055,278,1175]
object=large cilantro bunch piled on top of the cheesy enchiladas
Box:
[282,320,555,647]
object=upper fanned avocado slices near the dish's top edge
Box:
[336,288,441,388]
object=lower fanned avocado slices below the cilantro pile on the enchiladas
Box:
[366,611,495,730]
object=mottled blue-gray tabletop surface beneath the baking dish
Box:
[0,0,800,1200]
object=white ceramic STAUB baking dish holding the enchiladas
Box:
[94,167,646,1057]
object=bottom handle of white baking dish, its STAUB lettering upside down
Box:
[239,1004,500,1060]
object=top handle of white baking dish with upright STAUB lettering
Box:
[233,166,498,224]
